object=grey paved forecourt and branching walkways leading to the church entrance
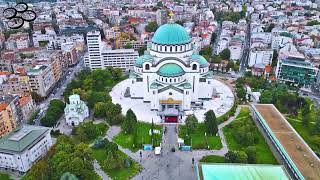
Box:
[95,106,241,180]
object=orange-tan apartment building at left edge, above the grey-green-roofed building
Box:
[0,95,22,137]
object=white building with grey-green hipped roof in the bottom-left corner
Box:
[0,125,52,172]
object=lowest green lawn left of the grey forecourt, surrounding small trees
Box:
[92,149,141,180]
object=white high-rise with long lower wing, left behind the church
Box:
[85,31,139,71]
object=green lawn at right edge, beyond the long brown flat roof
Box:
[287,118,320,153]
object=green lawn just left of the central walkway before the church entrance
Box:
[113,122,162,152]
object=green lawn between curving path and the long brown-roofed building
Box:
[223,108,278,164]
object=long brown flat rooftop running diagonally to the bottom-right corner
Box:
[253,104,320,179]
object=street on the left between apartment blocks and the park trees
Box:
[34,56,84,126]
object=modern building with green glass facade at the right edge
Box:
[276,56,318,87]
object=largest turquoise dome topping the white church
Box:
[152,23,191,44]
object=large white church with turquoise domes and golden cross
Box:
[127,16,214,122]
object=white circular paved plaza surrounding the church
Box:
[110,79,234,124]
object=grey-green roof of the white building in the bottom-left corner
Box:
[0,125,50,152]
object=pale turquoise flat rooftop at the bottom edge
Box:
[197,164,290,180]
